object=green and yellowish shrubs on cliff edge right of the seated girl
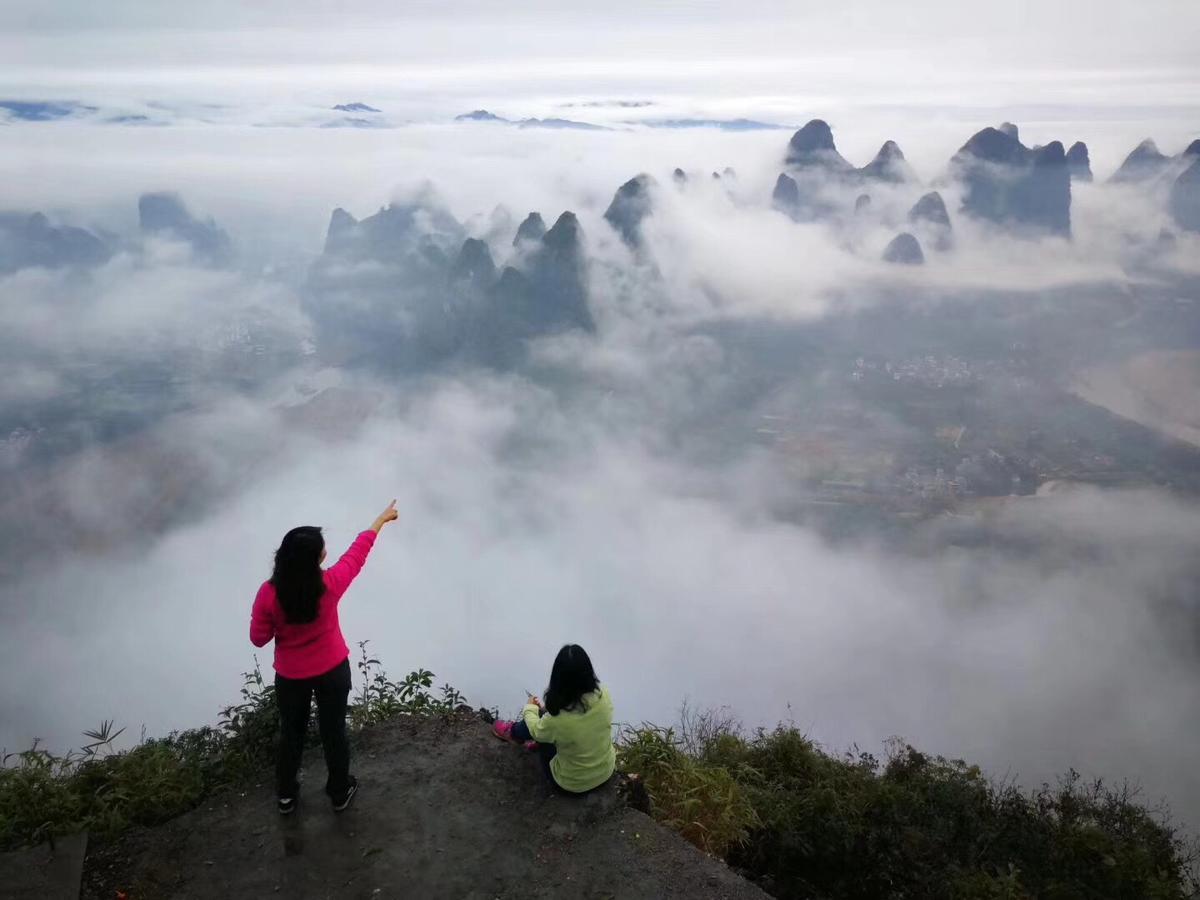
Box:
[618,713,1198,900]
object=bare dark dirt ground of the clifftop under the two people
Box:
[83,714,766,900]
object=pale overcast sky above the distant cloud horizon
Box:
[0,0,1200,119]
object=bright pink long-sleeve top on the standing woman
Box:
[250,530,376,678]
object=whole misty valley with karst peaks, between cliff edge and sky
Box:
[0,5,1200,844]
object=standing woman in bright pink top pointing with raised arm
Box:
[250,500,397,815]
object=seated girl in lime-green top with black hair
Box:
[492,643,617,794]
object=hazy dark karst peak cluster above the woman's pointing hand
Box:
[305,194,594,371]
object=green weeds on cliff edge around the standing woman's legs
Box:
[0,642,463,850]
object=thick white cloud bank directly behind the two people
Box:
[2,379,1200,825]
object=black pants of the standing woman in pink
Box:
[275,656,350,799]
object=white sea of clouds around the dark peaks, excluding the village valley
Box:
[0,3,1200,821]
